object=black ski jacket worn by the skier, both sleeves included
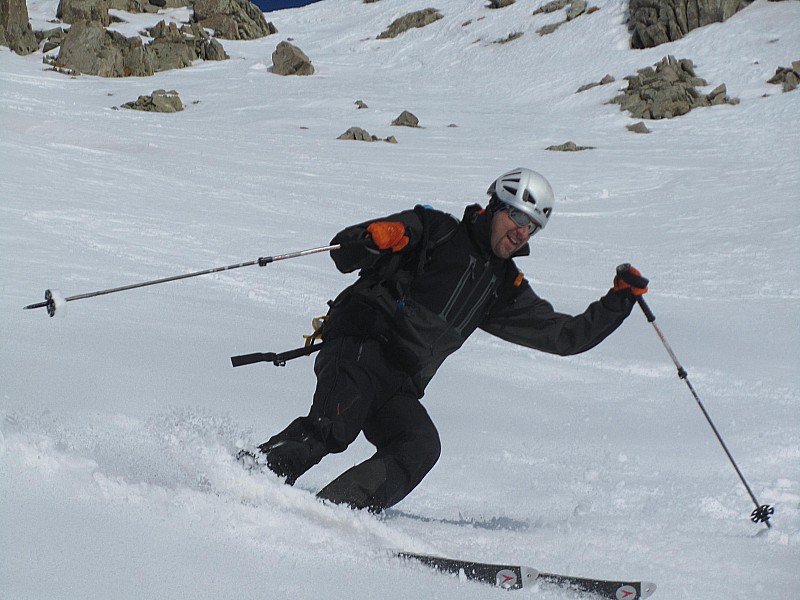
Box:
[323,204,634,397]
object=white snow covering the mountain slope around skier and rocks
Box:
[0,0,800,600]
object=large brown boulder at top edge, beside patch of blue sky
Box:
[192,0,278,40]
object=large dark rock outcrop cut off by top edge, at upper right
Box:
[628,0,749,48]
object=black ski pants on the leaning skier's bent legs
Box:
[260,337,441,512]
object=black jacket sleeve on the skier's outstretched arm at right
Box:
[480,282,635,356]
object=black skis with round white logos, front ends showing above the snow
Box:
[395,552,656,600]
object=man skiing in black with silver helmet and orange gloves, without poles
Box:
[250,168,647,512]
